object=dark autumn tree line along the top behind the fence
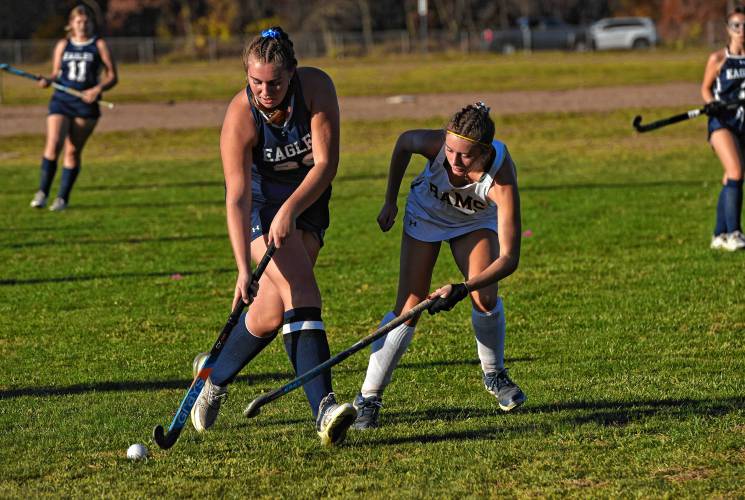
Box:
[0,0,734,42]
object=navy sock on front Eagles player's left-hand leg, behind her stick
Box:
[210,312,277,386]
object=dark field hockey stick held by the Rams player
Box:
[243,299,435,418]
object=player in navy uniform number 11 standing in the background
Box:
[31,5,117,211]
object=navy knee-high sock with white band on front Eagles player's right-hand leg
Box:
[282,307,332,418]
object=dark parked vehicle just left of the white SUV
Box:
[482,16,589,53]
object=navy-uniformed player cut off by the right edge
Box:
[701,6,745,251]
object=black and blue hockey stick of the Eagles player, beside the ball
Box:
[153,243,275,450]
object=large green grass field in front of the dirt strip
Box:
[0,52,745,498]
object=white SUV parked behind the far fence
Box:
[589,17,659,50]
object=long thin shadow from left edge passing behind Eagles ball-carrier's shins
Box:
[0,372,292,401]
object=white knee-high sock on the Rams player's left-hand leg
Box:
[360,311,415,398]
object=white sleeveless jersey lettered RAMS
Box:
[404,140,506,242]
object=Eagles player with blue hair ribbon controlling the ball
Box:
[192,27,356,444]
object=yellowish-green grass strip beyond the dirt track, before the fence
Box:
[0,49,708,104]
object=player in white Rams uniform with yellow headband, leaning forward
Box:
[354,103,526,429]
